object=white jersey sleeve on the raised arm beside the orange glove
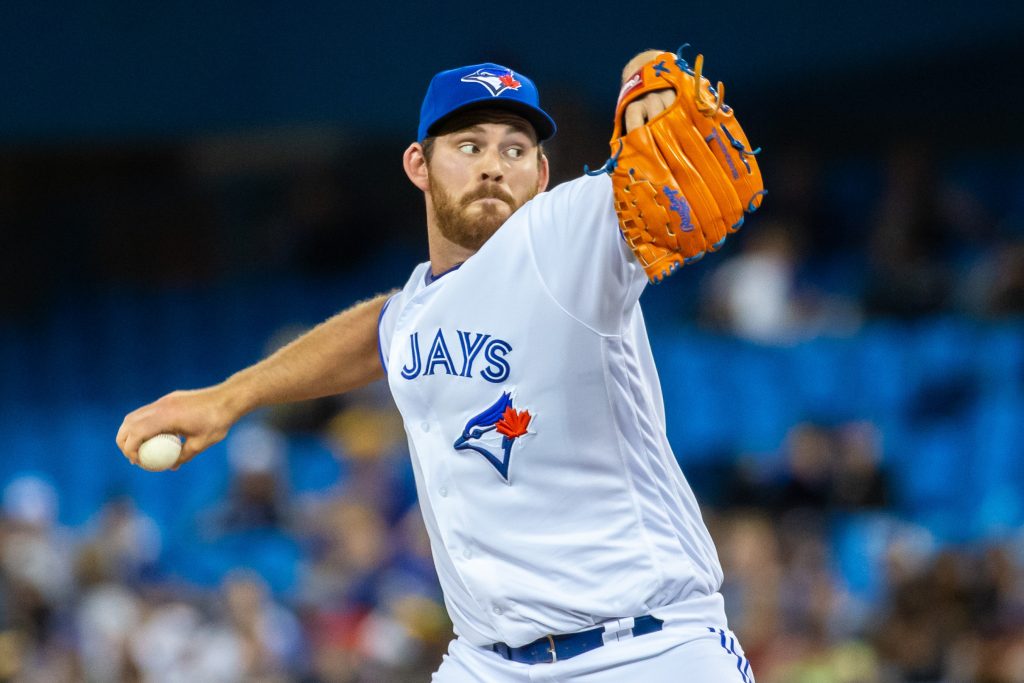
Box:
[527,169,648,334]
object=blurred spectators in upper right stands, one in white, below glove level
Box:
[700,142,1024,343]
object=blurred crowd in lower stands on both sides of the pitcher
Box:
[0,403,1024,683]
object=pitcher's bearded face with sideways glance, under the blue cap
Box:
[429,123,547,250]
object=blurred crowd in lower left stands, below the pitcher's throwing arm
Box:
[0,393,451,683]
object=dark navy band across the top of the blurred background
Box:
[6,0,1024,143]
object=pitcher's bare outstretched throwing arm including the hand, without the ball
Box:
[117,295,389,465]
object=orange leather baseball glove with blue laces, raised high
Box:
[601,45,765,282]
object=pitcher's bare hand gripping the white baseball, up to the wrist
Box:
[117,386,237,469]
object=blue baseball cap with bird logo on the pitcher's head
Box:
[417,62,556,142]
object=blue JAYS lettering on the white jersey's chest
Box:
[401,329,512,384]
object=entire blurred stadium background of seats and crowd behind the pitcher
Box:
[0,0,1024,683]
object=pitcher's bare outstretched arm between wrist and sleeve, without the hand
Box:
[218,295,388,419]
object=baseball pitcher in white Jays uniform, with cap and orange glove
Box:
[117,51,763,683]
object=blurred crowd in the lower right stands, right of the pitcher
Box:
[708,423,1024,683]
